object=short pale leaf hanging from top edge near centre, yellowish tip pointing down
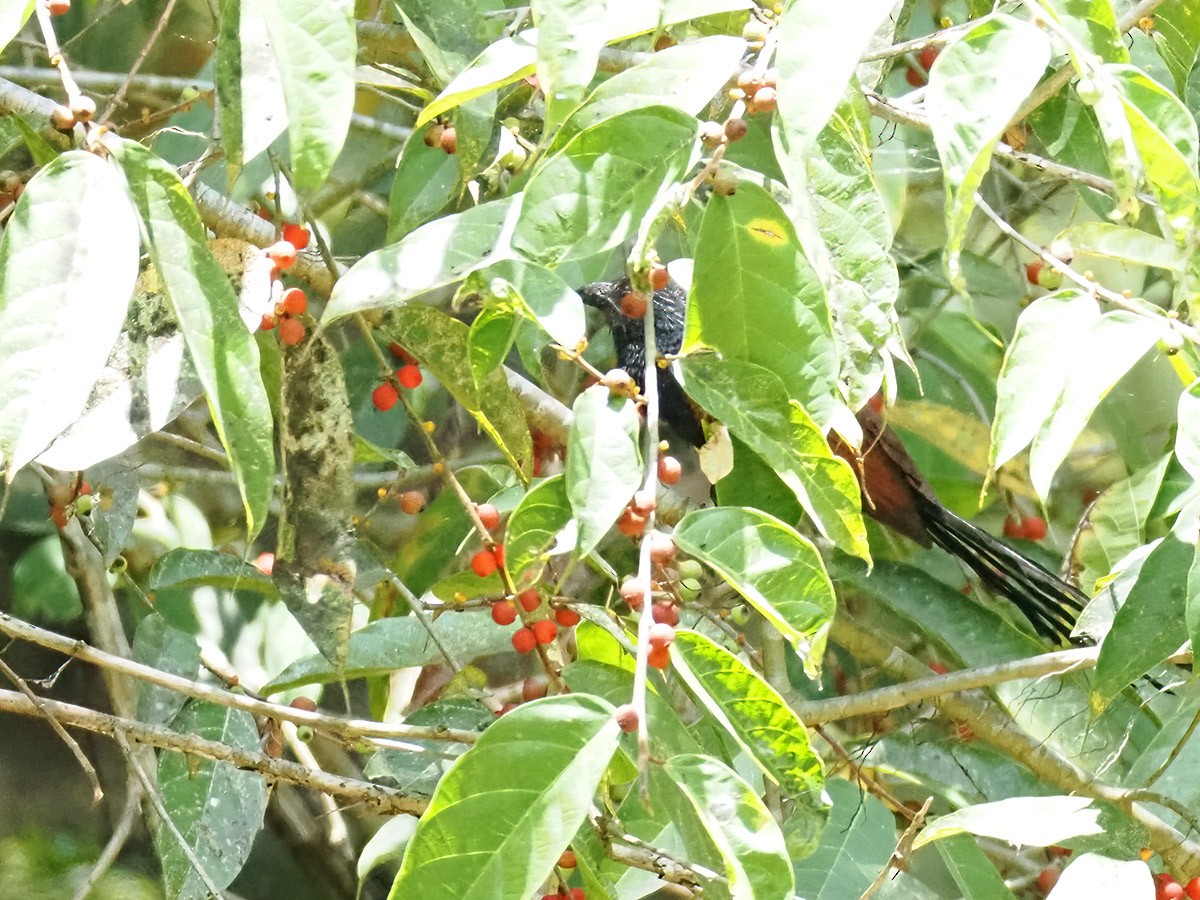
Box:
[530,0,607,133]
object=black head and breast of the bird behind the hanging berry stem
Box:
[578,278,704,446]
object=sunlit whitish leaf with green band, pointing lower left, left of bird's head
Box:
[322,197,520,326]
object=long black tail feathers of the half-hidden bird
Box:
[922,502,1087,643]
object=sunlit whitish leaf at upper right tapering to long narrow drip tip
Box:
[925,14,1050,290]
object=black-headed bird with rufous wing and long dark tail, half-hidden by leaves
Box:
[578,277,1088,644]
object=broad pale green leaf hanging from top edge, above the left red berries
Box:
[260,0,356,191]
